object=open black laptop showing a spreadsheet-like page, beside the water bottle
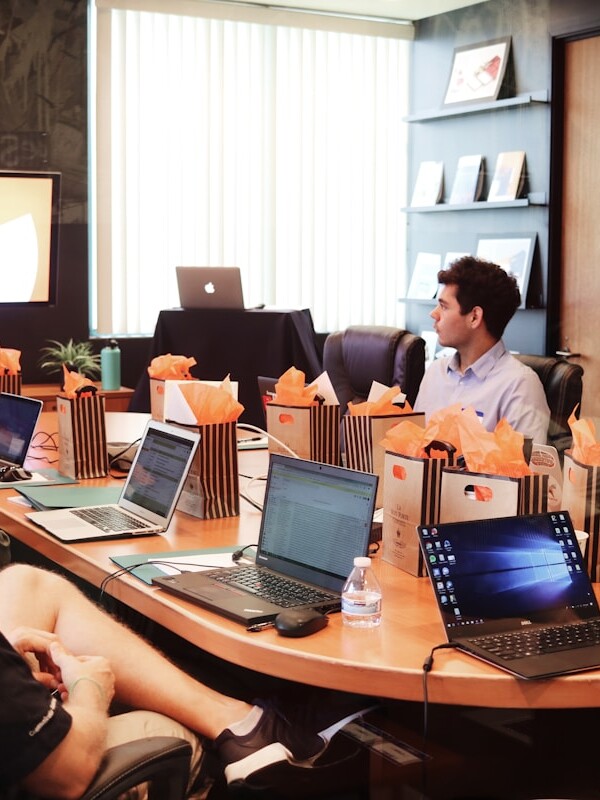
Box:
[154,454,377,625]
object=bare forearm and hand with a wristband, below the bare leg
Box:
[16,642,114,800]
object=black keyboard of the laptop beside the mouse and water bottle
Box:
[206,566,340,608]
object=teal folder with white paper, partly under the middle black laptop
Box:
[110,545,256,585]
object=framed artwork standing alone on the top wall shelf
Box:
[444,36,511,106]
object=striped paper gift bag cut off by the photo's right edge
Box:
[561,450,600,582]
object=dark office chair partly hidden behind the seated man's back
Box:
[516,354,583,456]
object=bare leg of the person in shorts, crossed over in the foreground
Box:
[0,564,252,739]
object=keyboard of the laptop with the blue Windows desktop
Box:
[467,619,600,661]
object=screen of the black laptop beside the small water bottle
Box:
[256,454,377,591]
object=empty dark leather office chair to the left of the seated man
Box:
[323,325,425,414]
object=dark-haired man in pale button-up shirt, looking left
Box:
[414,256,550,444]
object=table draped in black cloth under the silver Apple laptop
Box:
[129,308,321,428]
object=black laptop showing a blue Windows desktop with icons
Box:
[418,511,600,678]
